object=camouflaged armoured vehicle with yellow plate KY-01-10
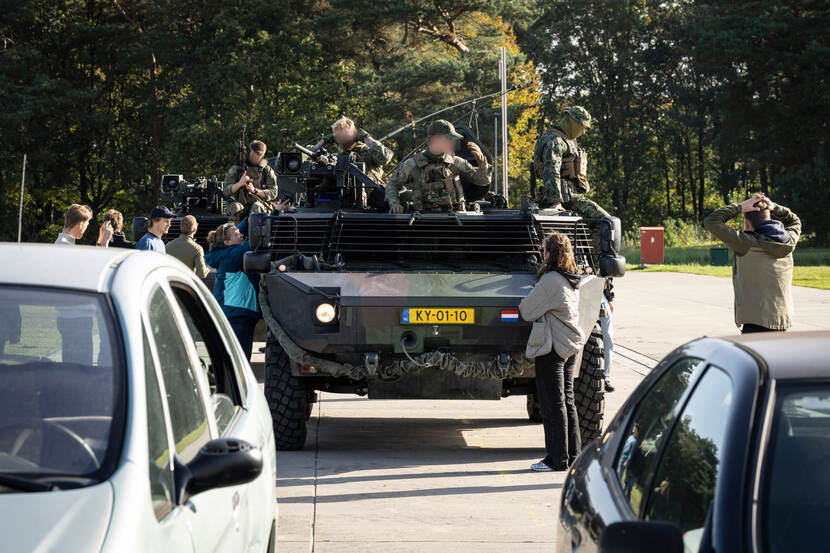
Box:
[245,144,625,449]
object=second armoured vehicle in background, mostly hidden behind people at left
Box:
[133,175,228,251]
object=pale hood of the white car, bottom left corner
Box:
[0,482,113,553]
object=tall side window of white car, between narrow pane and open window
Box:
[148,288,210,463]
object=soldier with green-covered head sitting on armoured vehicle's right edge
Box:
[533,106,608,219]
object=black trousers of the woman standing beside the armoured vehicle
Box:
[536,351,582,470]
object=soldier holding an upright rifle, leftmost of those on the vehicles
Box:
[224,140,279,221]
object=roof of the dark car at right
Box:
[724,331,830,380]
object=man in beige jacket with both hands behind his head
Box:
[703,194,801,333]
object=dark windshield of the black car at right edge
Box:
[761,384,830,553]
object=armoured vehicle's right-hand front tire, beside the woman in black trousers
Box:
[574,327,605,447]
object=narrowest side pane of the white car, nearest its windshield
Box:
[143,332,173,520]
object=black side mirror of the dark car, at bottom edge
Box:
[599,520,683,553]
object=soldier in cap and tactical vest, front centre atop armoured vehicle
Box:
[386,119,490,213]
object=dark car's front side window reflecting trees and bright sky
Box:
[645,365,732,551]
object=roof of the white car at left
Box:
[0,242,178,292]
